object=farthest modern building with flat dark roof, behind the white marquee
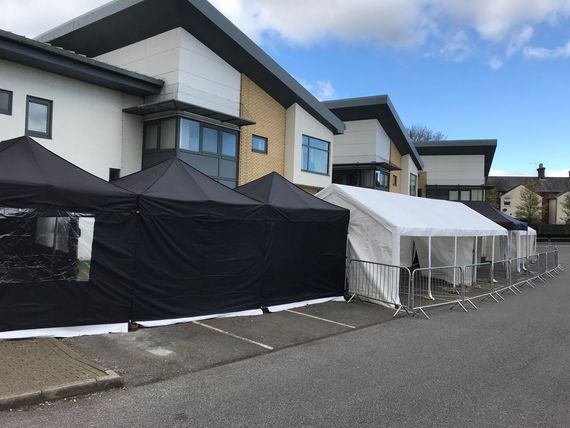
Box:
[410,140,497,201]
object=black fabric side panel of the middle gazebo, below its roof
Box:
[132,215,266,321]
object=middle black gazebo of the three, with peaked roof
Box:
[113,158,267,325]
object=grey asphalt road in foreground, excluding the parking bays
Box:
[0,247,570,427]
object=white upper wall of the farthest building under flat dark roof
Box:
[422,155,485,186]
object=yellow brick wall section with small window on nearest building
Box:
[239,75,286,185]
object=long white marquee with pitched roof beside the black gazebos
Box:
[317,184,507,304]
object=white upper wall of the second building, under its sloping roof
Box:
[334,119,390,164]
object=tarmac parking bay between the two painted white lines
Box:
[202,311,350,349]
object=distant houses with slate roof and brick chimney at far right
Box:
[487,164,570,224]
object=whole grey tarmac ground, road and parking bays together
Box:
[0,247,570,427]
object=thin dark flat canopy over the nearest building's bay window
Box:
[127,100,255,127]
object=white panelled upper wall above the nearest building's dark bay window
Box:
[97,28,241,116]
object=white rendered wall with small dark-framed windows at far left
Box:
[0,60,142,180]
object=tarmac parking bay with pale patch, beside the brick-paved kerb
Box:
[65,317,266,386]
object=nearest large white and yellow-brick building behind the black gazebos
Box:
[0,0,344,193]
